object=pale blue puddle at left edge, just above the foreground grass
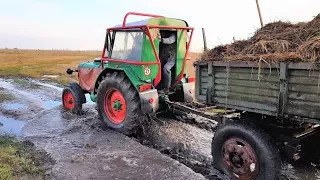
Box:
[0,116,26,136]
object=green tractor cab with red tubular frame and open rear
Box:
[101,13,194,98]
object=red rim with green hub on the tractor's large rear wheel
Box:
[104,89,127,124]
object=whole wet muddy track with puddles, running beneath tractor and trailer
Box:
[0,79,320,180]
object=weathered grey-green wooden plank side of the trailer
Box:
[195,61,320,123]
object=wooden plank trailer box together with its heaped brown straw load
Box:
[195,14,320,119]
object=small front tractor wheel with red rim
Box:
[62,83,85,115]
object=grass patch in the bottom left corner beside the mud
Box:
[0,137,43,180]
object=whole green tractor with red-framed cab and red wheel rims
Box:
[62,12,195,134]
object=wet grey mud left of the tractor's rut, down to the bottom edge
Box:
[0,77,205,180]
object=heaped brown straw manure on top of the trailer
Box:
[201,14,320,62]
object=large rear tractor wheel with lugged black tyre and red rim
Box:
[97,72,143,135]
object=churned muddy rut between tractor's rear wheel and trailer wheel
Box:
[130,116,230,180]
